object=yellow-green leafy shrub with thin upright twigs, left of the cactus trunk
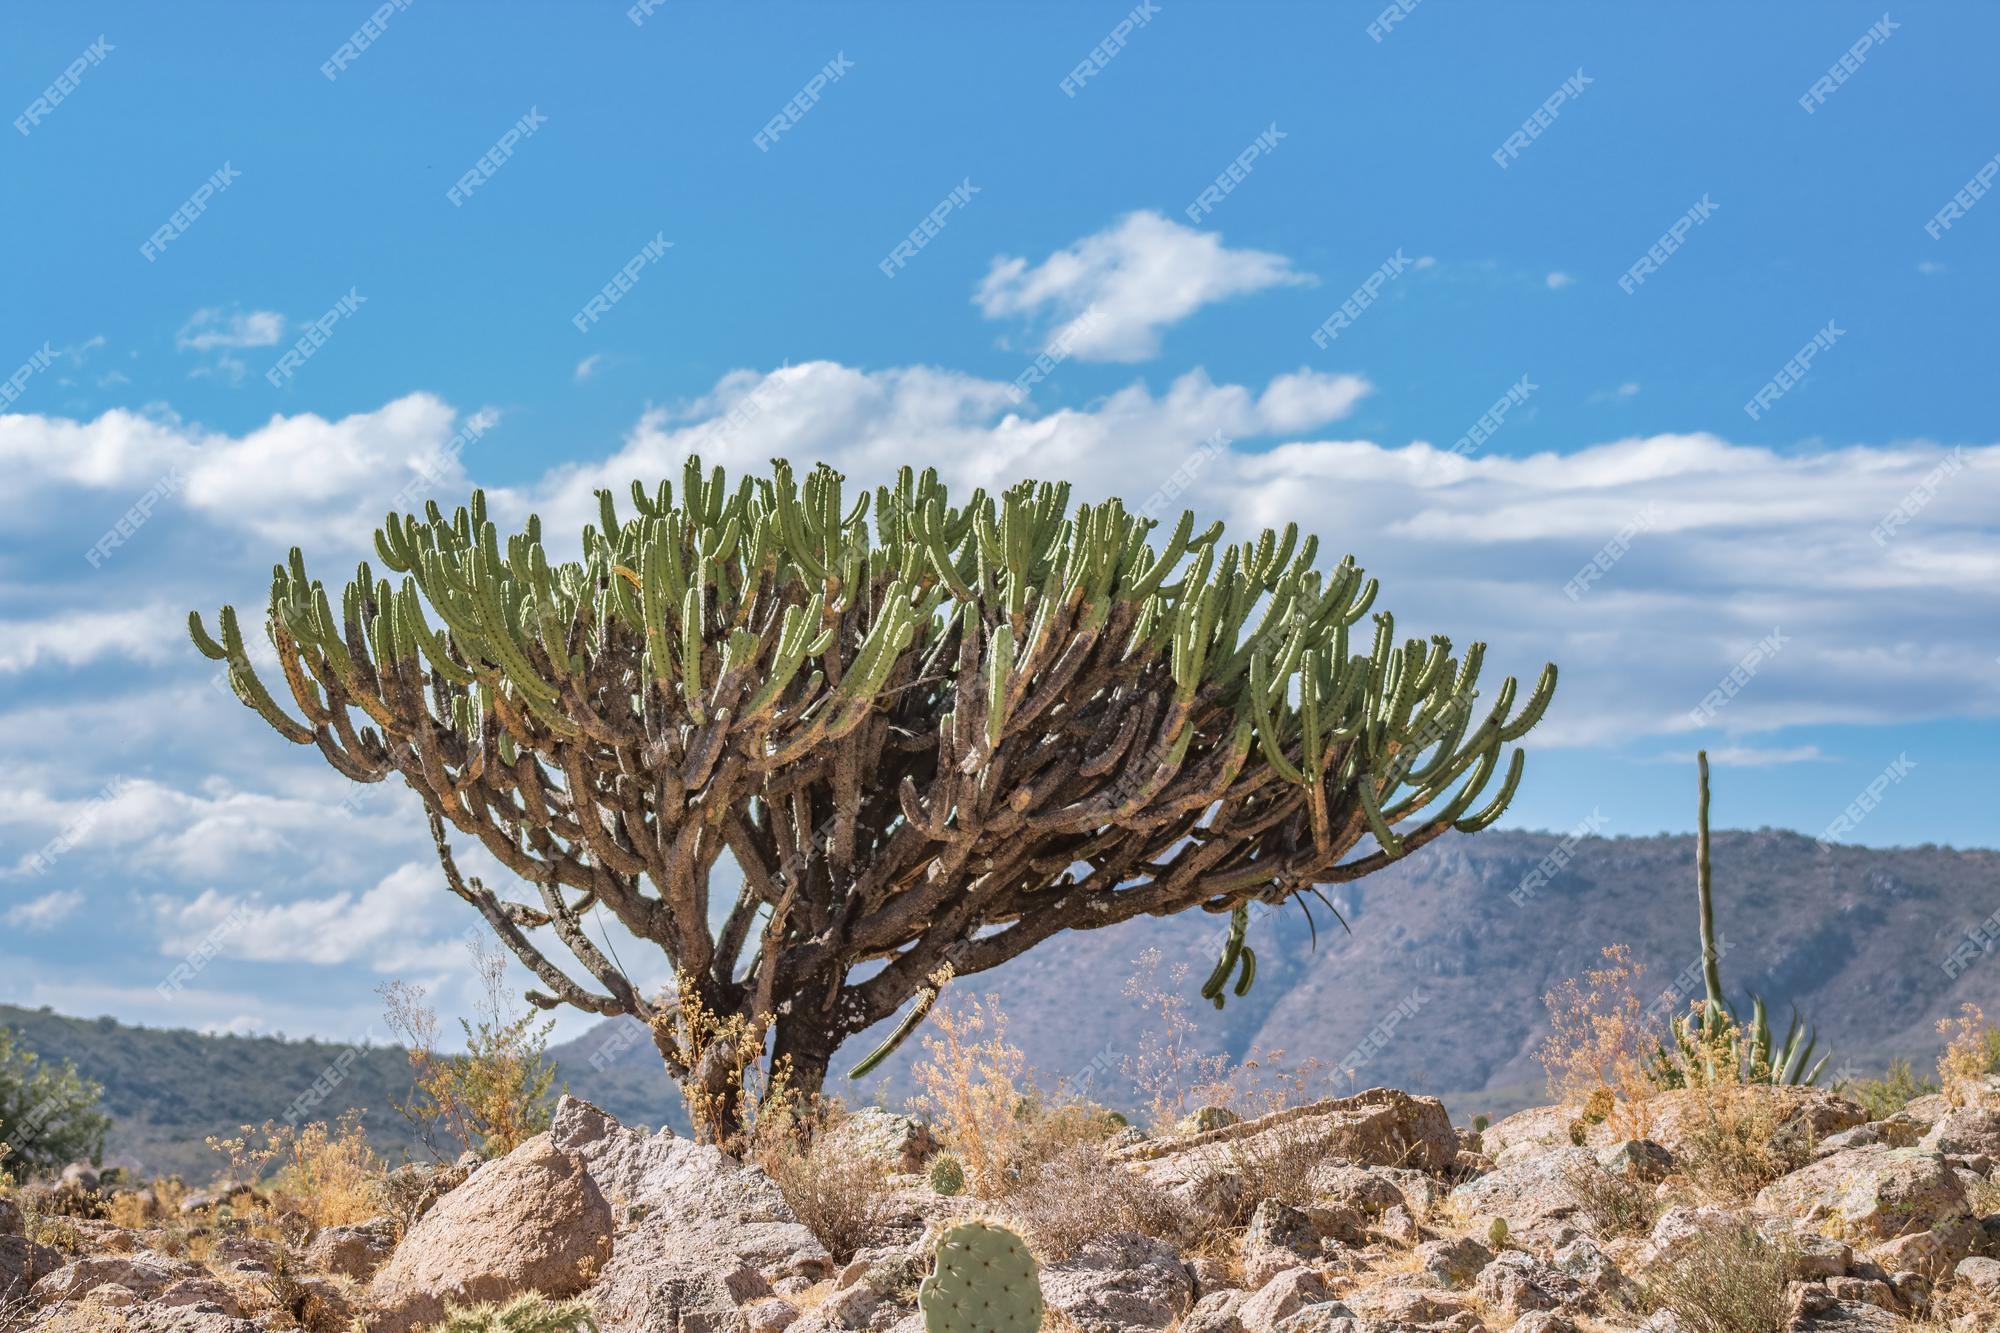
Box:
[378,945,556,1157]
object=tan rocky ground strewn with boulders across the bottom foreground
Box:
[0,1081,2000,1333]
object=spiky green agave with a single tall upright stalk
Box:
[1650,751,1832,1087]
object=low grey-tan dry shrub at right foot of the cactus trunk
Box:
[750,1099,894,1263]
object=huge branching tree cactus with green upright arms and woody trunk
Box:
[190,458,1556,1127]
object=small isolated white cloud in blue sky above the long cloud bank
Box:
[974,212,1314,360]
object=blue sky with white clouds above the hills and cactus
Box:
[0,0,2000,1033]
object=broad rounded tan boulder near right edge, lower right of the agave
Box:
[1756,1145,1966,1241]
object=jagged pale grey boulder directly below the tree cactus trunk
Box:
[548,1097,834,1281]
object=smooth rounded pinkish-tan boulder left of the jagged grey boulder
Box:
[370,1135,612,1333]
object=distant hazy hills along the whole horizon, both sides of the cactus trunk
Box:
[0,831,2000,1175]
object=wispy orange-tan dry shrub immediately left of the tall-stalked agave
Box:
[1536,945,1662,1139]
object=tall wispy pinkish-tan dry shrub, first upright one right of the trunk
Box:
[912,995,1032,1199]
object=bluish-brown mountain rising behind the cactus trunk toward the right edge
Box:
[570,829,2000,1119]
